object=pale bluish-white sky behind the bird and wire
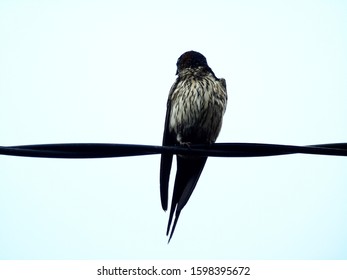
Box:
[0,0,347,259]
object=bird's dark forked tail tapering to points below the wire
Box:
[166,156,207,241]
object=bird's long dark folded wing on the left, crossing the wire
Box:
[160,83,176,211]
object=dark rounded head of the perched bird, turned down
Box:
[176,51,212,75]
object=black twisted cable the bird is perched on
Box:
[0,143,347,159]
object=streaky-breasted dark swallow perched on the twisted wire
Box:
[160,51,228,243]
